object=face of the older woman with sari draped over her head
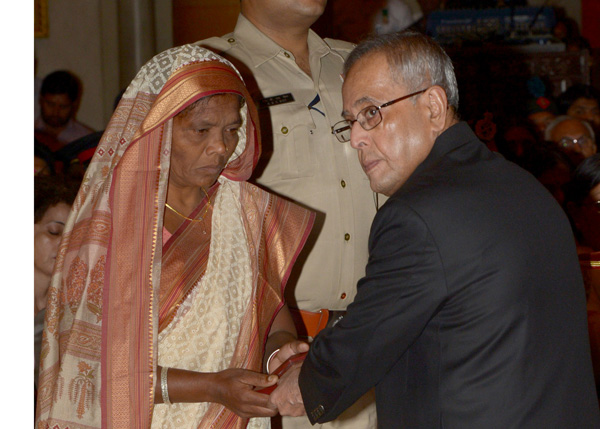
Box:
[169,94,242,188]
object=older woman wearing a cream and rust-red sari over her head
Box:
[37,45,314,428]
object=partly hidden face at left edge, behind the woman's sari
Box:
[33,203,71,276]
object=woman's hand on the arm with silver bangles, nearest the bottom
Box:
[212,369,277,418]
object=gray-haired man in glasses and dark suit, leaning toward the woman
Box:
[271,32,600,428]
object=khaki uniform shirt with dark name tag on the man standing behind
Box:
[198,15,375,311]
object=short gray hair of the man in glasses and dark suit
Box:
[344,30,458,114]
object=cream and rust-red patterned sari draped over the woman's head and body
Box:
[36,45,314,429]
